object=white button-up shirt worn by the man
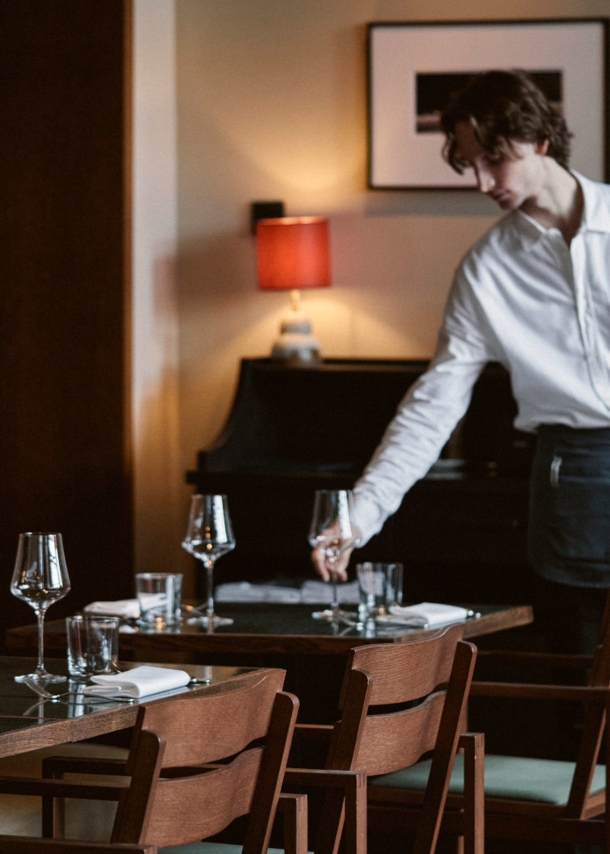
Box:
[354,173,610,542]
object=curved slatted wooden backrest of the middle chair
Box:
[316,624,477,852]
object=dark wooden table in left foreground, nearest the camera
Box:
[0,656,278,757]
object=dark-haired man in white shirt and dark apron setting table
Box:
[313,71,610,652]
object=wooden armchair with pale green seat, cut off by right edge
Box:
[369,599,610,851]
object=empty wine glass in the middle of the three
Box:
[182,495,235,632]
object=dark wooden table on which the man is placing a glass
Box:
[7,602,533,723]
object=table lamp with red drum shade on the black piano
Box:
[256,216,330,364]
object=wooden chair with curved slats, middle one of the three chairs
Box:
[285,625,483,854]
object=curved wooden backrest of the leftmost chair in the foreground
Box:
[112,670,298,854]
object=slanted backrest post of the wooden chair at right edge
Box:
[566,593,610,818]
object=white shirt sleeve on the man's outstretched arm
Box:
[354,267,494,545]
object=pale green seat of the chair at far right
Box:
[369,754,606,806]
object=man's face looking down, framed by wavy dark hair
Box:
[454,122,548,211]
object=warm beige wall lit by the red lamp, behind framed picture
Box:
[132,0,610,588]
